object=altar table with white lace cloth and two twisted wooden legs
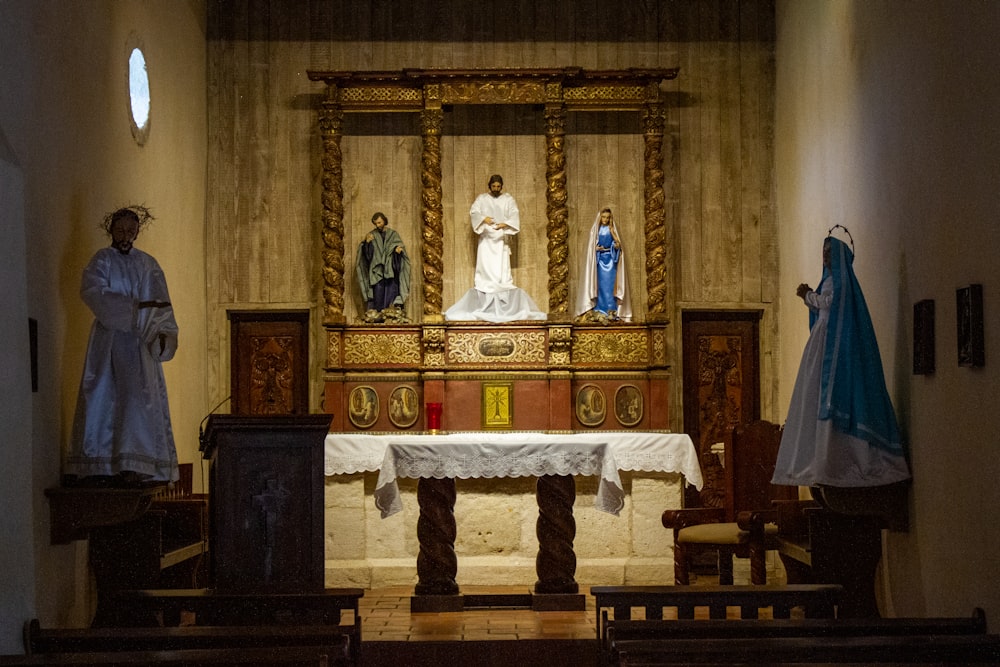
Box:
[326,431,702,611]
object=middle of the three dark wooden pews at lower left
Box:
[23,619,360,665]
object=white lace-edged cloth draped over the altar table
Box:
[325,431,702,517]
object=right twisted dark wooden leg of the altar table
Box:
[535,475,580,594]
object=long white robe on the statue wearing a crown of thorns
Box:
[63,248,178,482]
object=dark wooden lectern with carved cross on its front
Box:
[201,414,331,593]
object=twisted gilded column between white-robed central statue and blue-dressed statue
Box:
[545,104,572,322]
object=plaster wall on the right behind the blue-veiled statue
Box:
[775,0,1000,617]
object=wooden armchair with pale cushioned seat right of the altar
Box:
[662,420,798,585]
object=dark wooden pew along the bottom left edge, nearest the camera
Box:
[0,646,337,667]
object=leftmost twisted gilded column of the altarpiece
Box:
[319,103,352,324]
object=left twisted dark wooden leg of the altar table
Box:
[415,477,458,595]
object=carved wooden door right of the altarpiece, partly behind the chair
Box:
[681,310,761,507]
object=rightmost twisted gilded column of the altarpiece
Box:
[642,104,669,322]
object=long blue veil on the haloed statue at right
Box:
[809,236,903,456]
